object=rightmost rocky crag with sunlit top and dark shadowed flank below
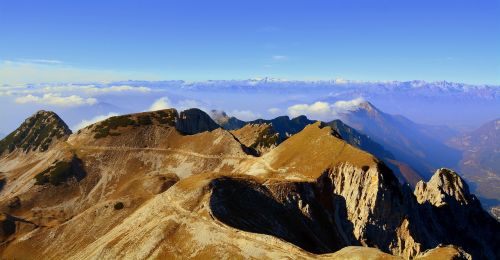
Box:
[414,169,500,259]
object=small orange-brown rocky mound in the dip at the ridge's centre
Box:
[231,124,279,154]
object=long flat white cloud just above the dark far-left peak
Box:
[14,93,97,107]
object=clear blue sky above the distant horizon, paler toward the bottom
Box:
[0,0,500,84]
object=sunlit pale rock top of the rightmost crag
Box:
[415,168,471,207]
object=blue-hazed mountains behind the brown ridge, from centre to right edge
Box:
[211,101,500,218]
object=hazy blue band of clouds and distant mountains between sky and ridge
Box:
[0,78,500,133]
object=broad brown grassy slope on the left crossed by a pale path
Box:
[0,108,258,257]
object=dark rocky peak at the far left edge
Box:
[0,110,71,154]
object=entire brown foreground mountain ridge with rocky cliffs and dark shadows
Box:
[0,105,500,259]
